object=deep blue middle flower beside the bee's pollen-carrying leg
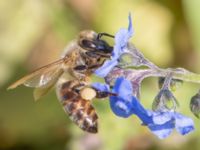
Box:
[92,77,147,118]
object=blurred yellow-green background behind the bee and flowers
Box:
[0,0,200,150]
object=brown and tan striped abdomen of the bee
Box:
[58,81,98,133]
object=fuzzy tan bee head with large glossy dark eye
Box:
[78,30,113,57]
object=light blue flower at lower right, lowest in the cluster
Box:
[147,111,194,139]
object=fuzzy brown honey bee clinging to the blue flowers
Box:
[8,30,114,133]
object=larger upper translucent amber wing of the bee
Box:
[8,58,65,89]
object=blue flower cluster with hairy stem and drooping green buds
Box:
[92,15,200,139]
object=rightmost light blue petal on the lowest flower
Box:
[174,113,194,135]
